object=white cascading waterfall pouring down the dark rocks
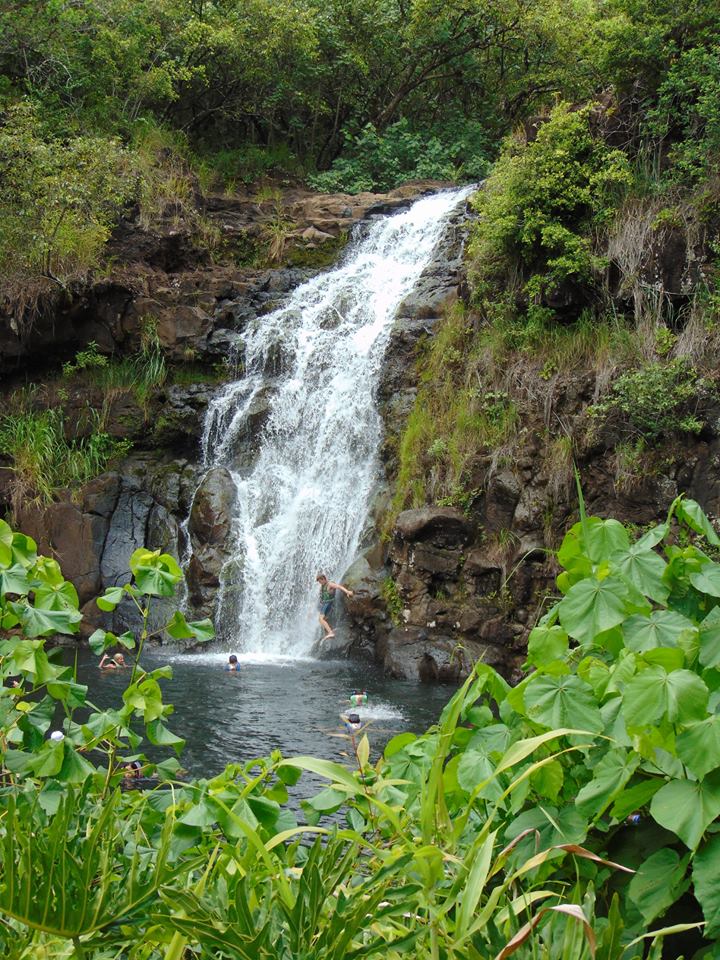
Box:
[195,188,470,656]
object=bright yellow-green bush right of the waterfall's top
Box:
[470,104,631,307]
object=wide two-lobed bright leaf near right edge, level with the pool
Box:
[623,666,710,727]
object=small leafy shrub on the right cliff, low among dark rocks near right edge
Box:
[590,357,707,441]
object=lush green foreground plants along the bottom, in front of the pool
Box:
[9,499,720,960]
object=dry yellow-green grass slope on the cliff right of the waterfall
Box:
[386,299,641,529]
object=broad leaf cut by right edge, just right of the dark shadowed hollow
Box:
[650,770,720,850]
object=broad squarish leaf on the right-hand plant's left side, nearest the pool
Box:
[525,673,603,732]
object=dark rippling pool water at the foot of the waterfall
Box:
[78,651,455,777]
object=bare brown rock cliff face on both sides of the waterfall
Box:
[0,184,720,680]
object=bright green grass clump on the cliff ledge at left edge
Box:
[0,404,130,506]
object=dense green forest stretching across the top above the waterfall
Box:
[0,0,720,296]
